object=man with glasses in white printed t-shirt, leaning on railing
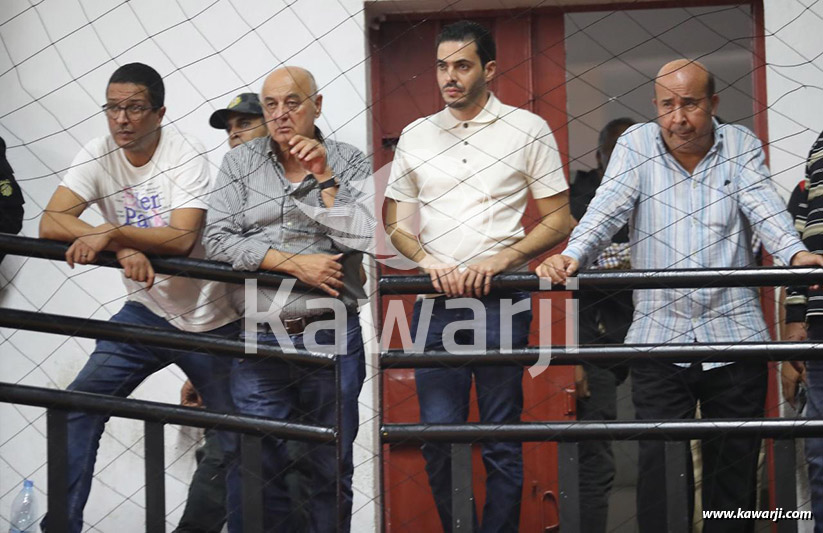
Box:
[40,63,239,533]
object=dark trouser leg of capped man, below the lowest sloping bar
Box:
[174,431,226,533]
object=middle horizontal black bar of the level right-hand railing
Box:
[380,342,823,369]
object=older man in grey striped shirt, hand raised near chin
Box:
[205,67,374,533]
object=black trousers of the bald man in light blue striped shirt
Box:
[632,362,767,533]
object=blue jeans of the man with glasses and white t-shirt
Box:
[43,302,240,533]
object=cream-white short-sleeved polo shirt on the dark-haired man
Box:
[386,94,568,268]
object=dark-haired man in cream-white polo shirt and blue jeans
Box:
[386,21,569,532]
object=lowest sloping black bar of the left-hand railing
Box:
[0,382,335,443]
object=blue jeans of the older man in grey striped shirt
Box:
[229,313,366,533]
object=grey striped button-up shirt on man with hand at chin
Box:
[204,136,375,318]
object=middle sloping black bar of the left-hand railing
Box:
[0,308,335,367]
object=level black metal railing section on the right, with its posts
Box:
[378,267,823,533]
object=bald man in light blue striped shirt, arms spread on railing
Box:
[537,59,823,533]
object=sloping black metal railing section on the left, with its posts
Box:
[0,233,343,533]
